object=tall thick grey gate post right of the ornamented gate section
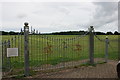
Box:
[89,26,94,64]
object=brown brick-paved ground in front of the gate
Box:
[33,60,117,78]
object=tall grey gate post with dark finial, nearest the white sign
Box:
[24,22,29,76]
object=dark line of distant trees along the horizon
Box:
[0,31,120,35]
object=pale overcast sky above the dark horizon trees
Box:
[0,2,118,32]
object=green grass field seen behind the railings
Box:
[2,35,118,68]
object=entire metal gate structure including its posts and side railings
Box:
[2,23,118,76]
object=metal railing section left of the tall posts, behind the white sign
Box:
[2,33,24,76]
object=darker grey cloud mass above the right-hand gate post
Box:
[88,2,118,29]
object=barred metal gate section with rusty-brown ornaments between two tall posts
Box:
[29,28,89,70]
